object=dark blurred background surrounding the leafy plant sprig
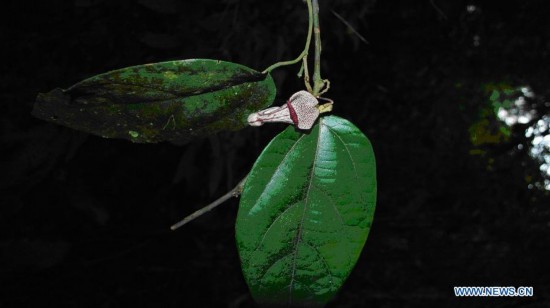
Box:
[0,0,550,308]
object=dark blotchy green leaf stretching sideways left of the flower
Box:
[33,59,276,143]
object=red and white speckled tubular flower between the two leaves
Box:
[248,91,320,130]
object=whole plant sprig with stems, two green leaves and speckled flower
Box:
[33,0,376,306]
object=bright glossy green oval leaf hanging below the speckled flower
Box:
[236,116,376,305]
